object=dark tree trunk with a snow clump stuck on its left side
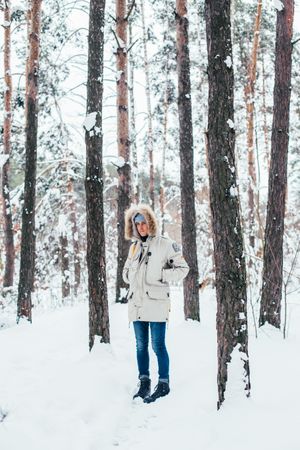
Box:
[85,0,110,350]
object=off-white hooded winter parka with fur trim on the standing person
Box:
[123,205,189,322]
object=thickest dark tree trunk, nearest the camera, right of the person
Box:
[205,0,250,407]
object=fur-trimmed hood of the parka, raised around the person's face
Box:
[125,203,158,240]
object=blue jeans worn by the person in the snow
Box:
[133,321,169,381]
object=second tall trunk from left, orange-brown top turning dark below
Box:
[17,0,42,321]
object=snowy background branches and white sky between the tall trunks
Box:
[0,1,300,304]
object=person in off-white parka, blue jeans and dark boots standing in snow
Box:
[123,204,189,403]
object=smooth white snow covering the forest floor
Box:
[0,288,300,450]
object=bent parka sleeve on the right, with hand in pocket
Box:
[162,240,190,283]
